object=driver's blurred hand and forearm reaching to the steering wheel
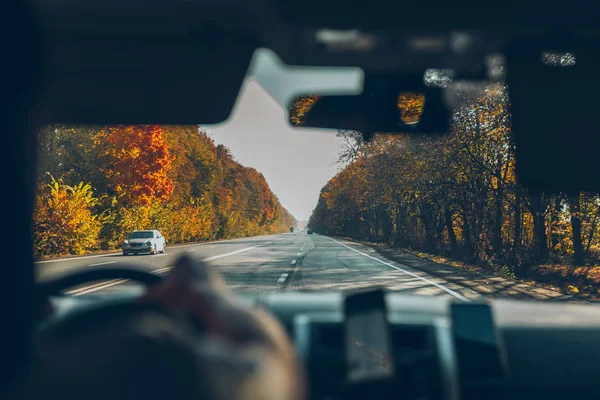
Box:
[140,257,305,400]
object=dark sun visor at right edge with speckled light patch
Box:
[505,39,600,192]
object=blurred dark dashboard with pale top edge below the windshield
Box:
[45,291,600,400]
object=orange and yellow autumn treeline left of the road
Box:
[33,125,296,257]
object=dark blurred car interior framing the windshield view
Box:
[0,0,600,399]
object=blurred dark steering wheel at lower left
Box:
[34,264,211,400]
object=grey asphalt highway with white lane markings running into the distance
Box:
[36,231,576,301]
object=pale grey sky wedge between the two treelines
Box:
[204,80,340,220]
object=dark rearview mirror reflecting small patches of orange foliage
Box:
[288,72,450,138]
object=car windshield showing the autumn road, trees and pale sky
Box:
[33,54,600,301]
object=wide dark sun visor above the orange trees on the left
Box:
[45,30,258,124]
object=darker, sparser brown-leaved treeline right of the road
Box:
[309,85,600,272]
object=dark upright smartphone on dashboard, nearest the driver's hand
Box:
[344,290,394,386]
